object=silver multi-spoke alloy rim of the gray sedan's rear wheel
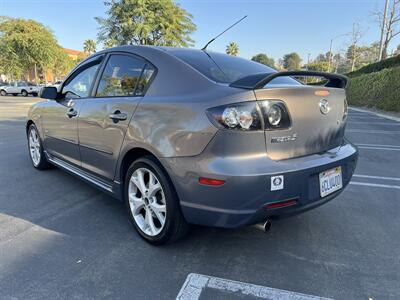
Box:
[128,167,167,236]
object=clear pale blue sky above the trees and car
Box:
[0,0,400,62]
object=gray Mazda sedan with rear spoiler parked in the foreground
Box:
[26,46,358,244]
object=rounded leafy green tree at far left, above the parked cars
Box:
[0,17,61,81]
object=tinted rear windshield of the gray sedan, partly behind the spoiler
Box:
[170,49,300,86]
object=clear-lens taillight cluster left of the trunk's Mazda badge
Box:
[207,100,291,131]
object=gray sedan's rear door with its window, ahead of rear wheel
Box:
[79,53,154,180]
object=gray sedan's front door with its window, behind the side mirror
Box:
[42,57,101,166]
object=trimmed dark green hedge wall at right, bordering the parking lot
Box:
[347,67,400,112]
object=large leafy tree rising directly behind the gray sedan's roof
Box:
[95,0,196,47]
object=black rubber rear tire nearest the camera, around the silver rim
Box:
[124,156,189,245]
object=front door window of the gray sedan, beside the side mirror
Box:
[61,64,99,99]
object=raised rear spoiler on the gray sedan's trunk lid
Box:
[229,71,348,90]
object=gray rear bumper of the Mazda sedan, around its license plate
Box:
[162,143,358,228]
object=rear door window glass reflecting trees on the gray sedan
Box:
[96,55,145,97]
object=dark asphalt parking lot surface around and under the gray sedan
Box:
[0,97,400,299]
